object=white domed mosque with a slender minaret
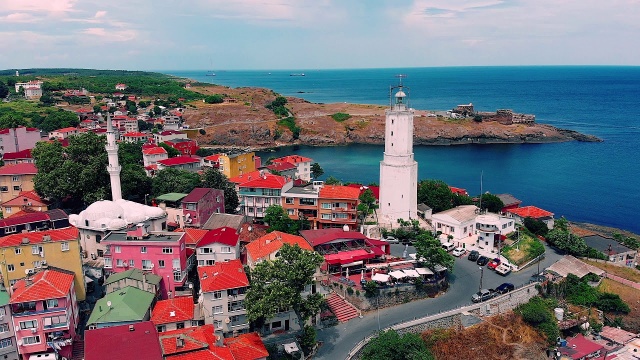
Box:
[69,115,167,268]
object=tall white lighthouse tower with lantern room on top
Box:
[380,79,418,224]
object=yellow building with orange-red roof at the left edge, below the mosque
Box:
[0,227,86,301]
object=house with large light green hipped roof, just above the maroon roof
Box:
[87,286,156,330]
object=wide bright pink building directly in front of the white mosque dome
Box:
[102,224,189,299]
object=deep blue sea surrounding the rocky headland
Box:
[164,66,640,234]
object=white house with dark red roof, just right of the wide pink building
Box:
[196,227,240,266]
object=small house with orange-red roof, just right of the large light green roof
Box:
[151,296,204,333]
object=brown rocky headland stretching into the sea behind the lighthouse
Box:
[183,86,602,148]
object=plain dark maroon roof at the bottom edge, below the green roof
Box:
[84,321,162,360]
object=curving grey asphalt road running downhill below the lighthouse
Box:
[315,245,562,360]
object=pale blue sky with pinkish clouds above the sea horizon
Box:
[0,0,640,70]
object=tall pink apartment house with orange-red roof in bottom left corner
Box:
[9,268,79,359]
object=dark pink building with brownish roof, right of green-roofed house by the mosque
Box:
[182,188,224,228]
